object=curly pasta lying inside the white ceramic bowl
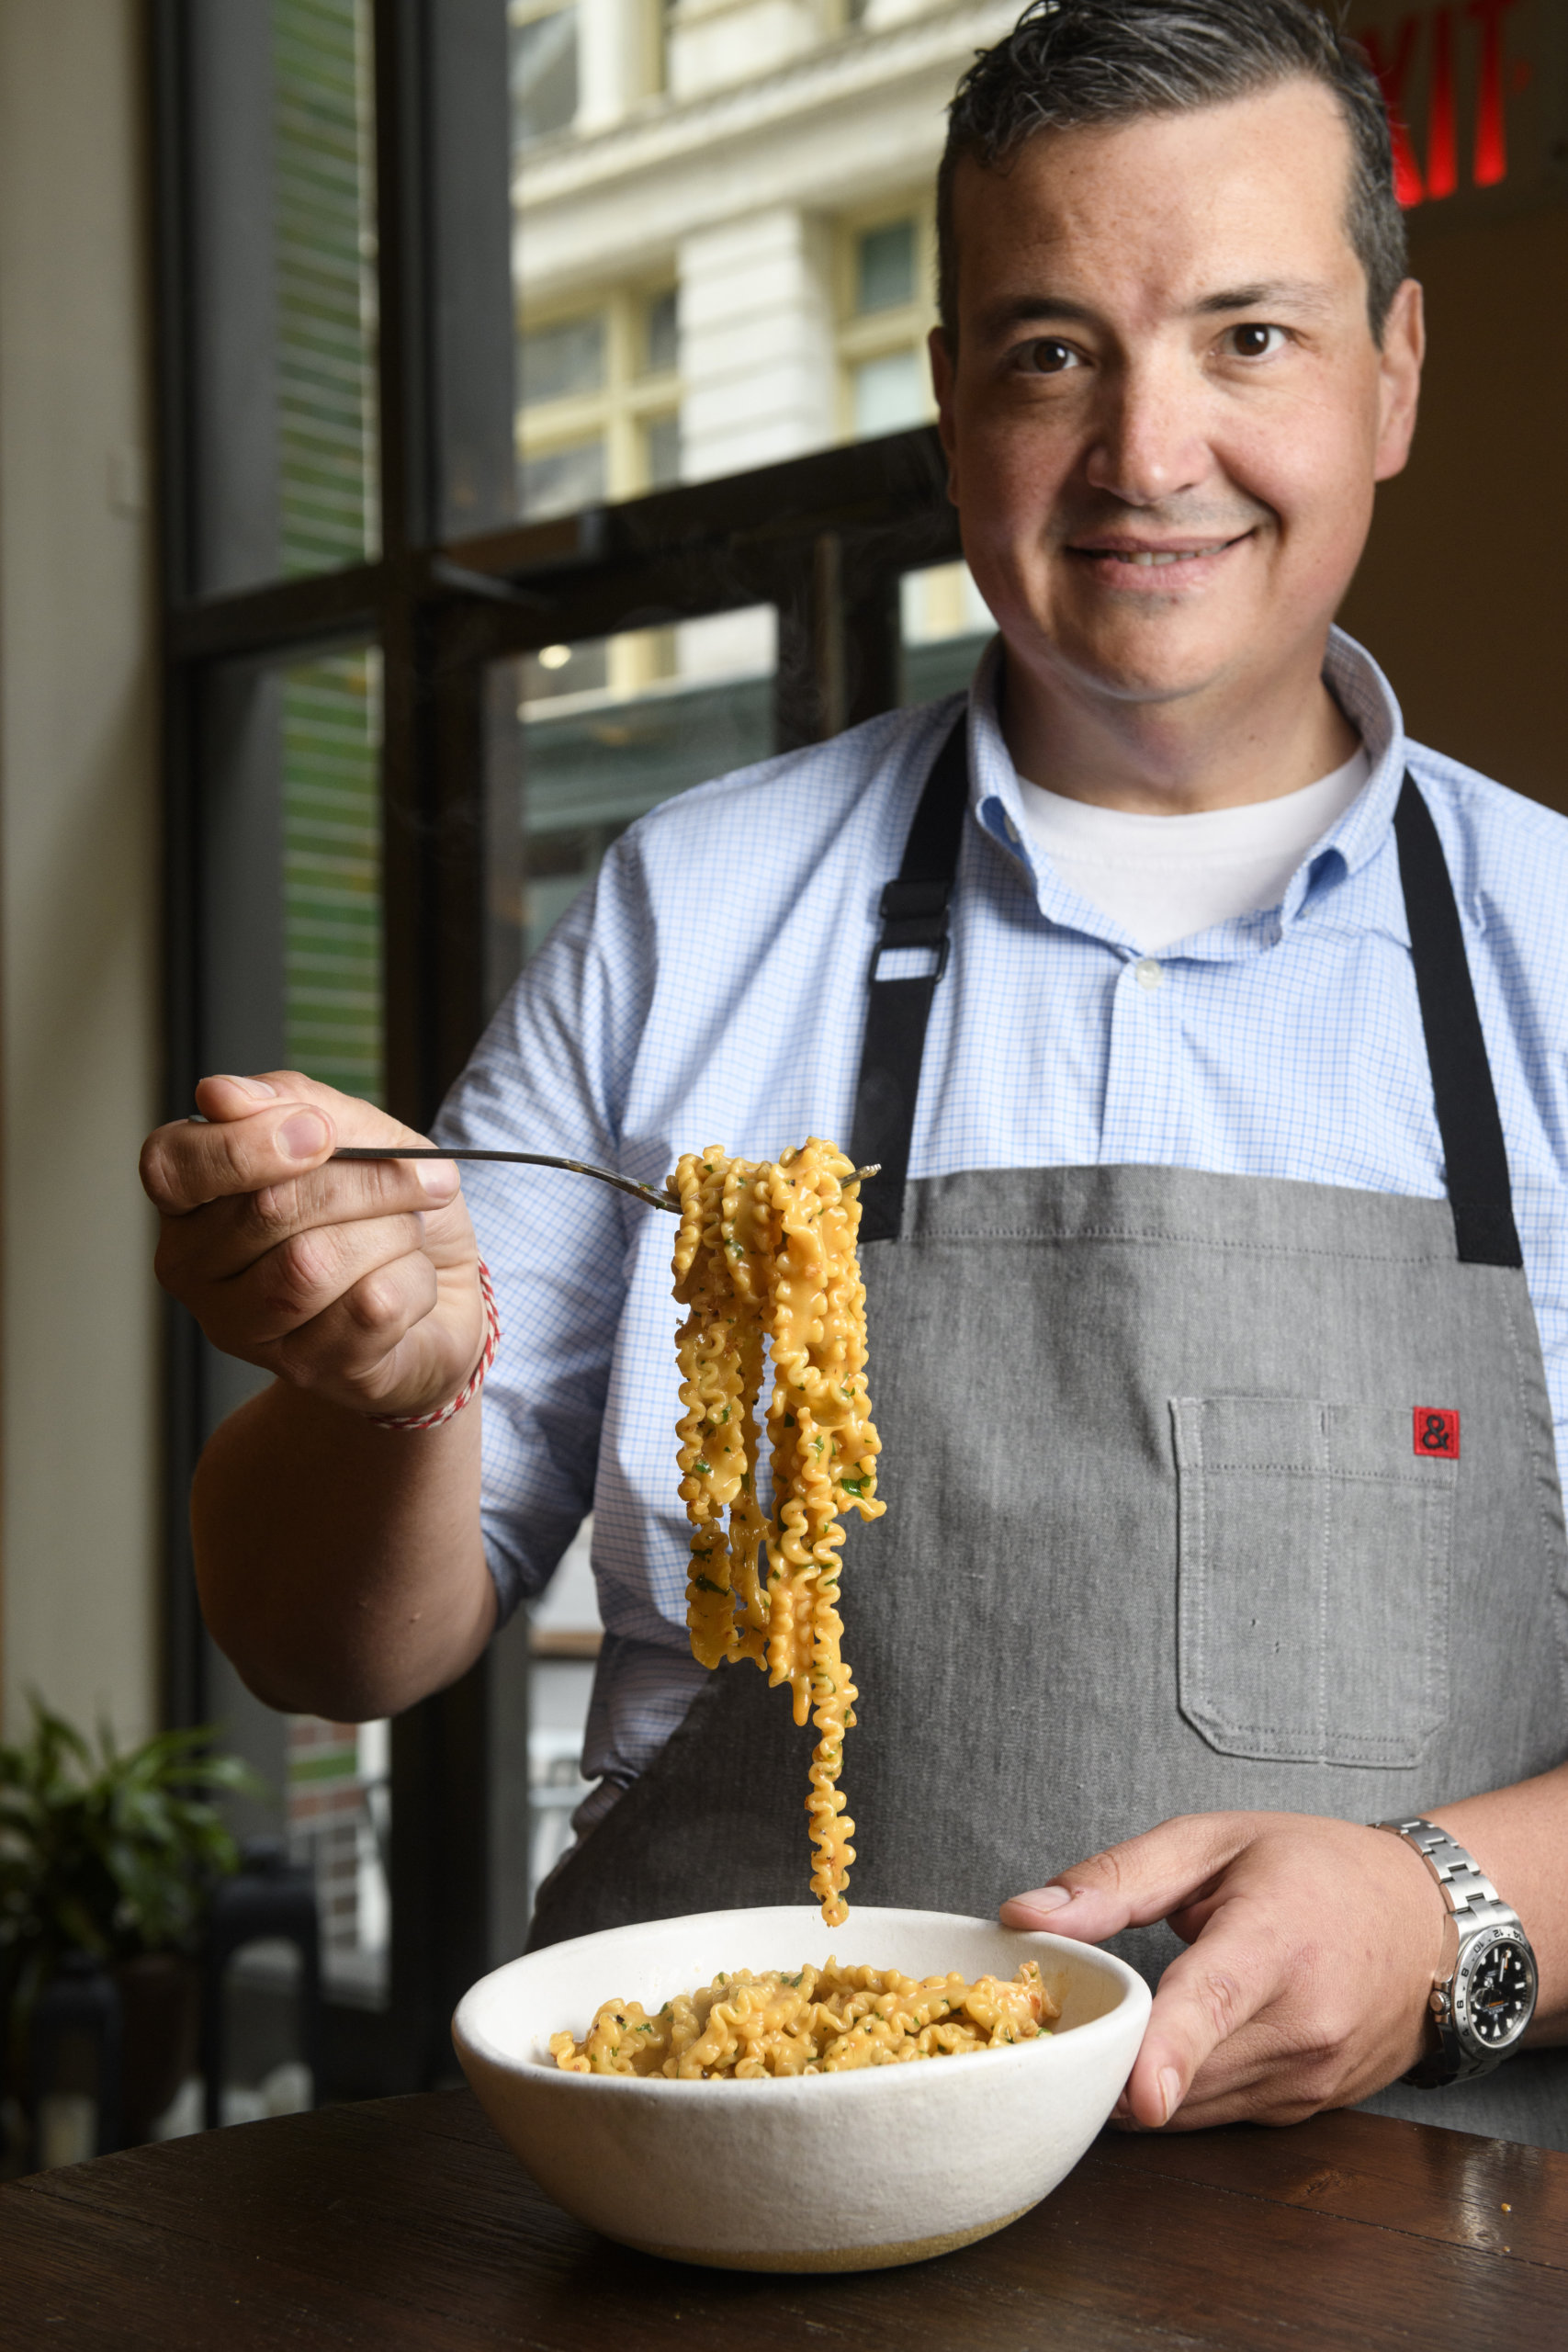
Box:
[550,1959,1060,2082]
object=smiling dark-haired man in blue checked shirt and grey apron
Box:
[146,0,1568,2145]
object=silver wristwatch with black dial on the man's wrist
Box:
[1373,1820,1535,2088]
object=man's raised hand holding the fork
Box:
[141,1070,484,1414]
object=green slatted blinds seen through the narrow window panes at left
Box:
[273,0,383,1101]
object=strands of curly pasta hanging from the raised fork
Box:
[670,1136,886,1927]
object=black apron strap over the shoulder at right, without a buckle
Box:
[1394,769,1523,1265]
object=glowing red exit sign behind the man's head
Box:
[1349,0,1568,207]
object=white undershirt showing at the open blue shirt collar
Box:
[1018,746,1371,953]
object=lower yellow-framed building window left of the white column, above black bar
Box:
[517,287,680,522]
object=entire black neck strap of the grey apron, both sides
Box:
[849,710,1523,1265]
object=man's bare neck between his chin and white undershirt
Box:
[997,650,1357,816]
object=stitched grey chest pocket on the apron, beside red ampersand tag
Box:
[1170,1397,1458,1769]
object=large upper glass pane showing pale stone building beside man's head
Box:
[510,0,944,515]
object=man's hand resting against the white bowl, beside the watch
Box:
[1001,1814,1446,2131]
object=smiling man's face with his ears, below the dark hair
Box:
[933,80,1420,703]
